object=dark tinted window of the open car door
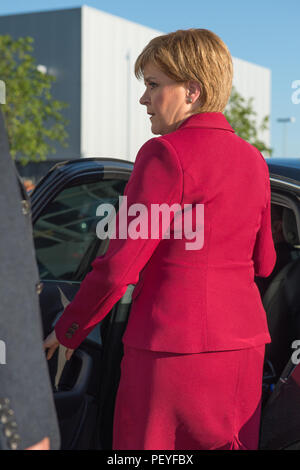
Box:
[33,179,126,281]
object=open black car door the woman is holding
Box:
[31,158,133,449]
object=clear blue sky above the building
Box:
[0,0,300,157]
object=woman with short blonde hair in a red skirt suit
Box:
[45,29,276,450]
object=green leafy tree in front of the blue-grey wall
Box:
[0,35,68,165]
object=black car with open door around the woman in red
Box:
[31,158,300,449]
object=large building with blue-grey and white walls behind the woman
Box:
[0,6,271,161]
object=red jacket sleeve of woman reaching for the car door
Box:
[55,137,183,349]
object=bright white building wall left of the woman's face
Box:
[81,6,161,161]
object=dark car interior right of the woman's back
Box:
[256,203,300,390]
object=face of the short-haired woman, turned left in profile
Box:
[140,63,192,135]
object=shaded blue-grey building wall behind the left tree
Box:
[0,8,81,161]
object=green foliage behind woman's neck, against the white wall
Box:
[224,87,272,156]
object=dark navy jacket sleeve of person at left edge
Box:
[0,108,60,450]
